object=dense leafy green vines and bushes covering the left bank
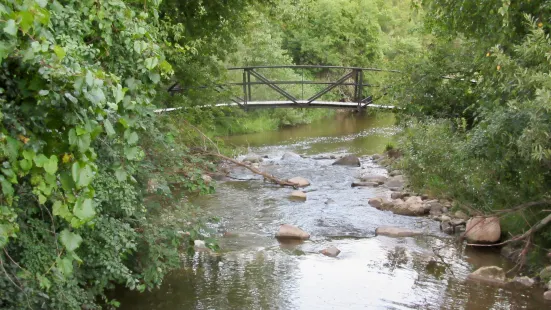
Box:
[0,0,231,309]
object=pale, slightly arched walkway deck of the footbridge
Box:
[155,100,396,113]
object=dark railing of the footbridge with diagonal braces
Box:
[227,65,400,109]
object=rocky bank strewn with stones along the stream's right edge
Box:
[370,150,551,300]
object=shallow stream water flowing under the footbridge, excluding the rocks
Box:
[118,114,550,309]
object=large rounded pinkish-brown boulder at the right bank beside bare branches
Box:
[465,216,501,243]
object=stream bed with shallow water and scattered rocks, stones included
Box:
[115,113,549,309]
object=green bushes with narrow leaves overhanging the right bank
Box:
[394,0,551,245]
